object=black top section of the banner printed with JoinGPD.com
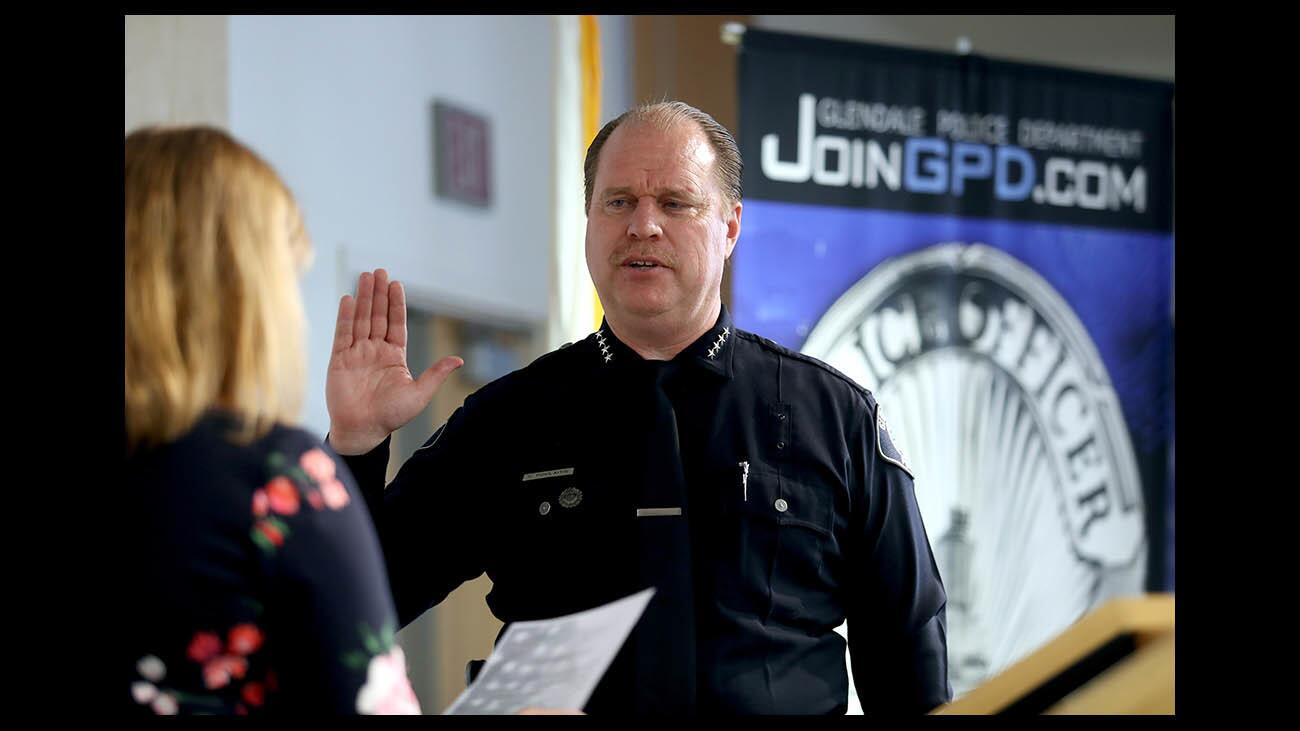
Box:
[740,30,1174,232]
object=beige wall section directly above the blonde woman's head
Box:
[125,16,229,131]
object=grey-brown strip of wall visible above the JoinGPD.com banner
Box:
[751,16,1174,81]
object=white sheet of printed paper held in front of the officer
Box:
[442,588,654,715]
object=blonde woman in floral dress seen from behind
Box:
[120,127,420,714]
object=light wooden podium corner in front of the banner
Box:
[932,594,1174,714]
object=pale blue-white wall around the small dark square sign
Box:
[230,16,555,433]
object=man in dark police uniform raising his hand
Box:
[326,101,952,715]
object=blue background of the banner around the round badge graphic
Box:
[732,200,1174,588]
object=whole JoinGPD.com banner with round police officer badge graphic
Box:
[732,29,1174,695]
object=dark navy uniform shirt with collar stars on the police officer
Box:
[346,307,952,714]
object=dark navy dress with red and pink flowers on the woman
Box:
[118,412,420,715]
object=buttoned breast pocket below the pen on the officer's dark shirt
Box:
[737,467,835,622]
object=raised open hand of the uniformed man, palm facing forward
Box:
[325,269,464,454]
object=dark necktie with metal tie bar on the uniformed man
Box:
[632,362,696,717]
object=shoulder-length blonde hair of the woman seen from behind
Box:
[125,126,311,449]
